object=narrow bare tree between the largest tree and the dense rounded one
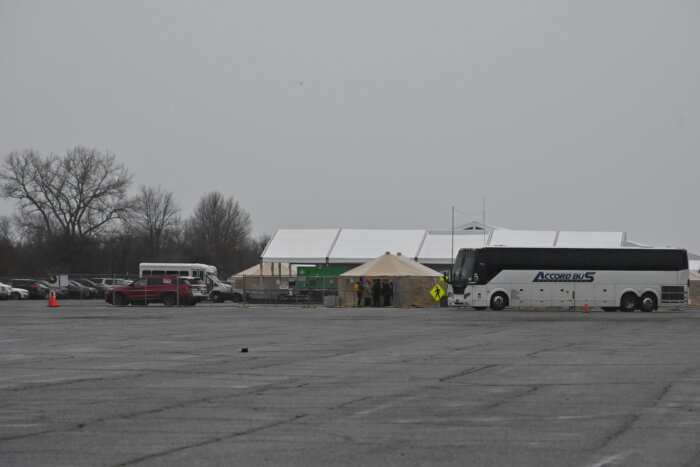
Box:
[131,185,180,261]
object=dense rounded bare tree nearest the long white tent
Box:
[185,191,251,270]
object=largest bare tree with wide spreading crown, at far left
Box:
[0,146,132,240]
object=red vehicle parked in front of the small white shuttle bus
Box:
[105,276,208,306]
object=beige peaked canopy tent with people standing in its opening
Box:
[338,252,446,307]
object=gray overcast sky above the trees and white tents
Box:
[0,0,700,253]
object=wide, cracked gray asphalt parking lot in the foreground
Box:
[0,301,700,466]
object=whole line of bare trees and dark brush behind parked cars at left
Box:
[0,146,269,277]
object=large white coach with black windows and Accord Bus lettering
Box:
[448,247,689,311]
